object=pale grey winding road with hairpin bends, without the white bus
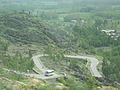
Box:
[3,54,102,80]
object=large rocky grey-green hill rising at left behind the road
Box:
[0,13,69,46]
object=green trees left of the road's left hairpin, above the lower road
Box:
[0,52,34,72]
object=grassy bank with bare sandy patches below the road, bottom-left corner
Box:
[0,68,49,90]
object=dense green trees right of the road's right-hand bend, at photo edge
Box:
[102,46,120,82]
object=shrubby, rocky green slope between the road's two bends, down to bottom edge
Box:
[41,45,100,90]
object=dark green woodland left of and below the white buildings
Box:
[73,19,120,49]
